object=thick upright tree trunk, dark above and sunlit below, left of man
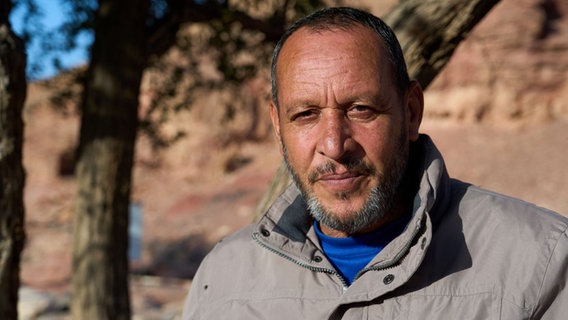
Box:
[71,0,149,319]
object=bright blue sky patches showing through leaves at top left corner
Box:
[10,0,92,79]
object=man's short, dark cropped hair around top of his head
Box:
[271,7,410,107]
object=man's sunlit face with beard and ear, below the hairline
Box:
[271,27,422,236]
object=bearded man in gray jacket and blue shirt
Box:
[183,8,568,319]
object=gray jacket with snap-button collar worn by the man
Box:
[183,136,568,320]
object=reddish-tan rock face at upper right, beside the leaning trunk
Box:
[426,0,568,124]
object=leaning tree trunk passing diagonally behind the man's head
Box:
[255,0,499,220]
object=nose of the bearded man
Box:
[318,110,352,160]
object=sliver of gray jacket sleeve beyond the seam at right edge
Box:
[532,227,568,320]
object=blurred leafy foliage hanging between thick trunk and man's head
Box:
[141,0,338,149]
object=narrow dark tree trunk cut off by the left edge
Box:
[0,0,27,320]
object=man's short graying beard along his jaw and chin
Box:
[282,132,408,234]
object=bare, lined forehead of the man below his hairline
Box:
[276,25,391,104]
